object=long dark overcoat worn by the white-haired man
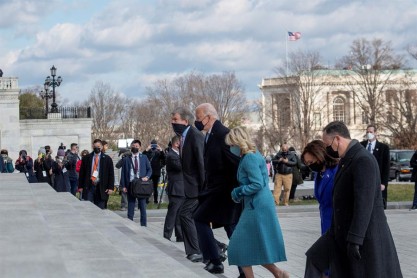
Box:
[194,121,242,228]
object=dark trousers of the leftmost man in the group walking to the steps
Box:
[164,195,185,240]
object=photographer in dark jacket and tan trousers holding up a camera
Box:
[272,144,297,206]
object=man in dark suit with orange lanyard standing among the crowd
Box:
[78,139,114,209]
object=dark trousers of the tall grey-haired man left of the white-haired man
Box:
[179,198,200,255]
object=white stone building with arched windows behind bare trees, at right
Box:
[259,70,417,151]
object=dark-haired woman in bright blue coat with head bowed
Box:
[301,140,339,234]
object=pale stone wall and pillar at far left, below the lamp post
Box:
[0,77,92,161]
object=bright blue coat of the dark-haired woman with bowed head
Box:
[314,166,338,234]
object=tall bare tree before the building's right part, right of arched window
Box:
[336,38,403,124]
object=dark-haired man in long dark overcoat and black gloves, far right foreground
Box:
[305,121,402,278]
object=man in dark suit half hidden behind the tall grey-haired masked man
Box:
[164,136,185,242]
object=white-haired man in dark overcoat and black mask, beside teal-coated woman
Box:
[194,103,241,273]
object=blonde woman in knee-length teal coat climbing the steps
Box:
[226,127,289,278]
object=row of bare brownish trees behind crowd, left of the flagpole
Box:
[88,72,248,147]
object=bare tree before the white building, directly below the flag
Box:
[261,51,327,149]
